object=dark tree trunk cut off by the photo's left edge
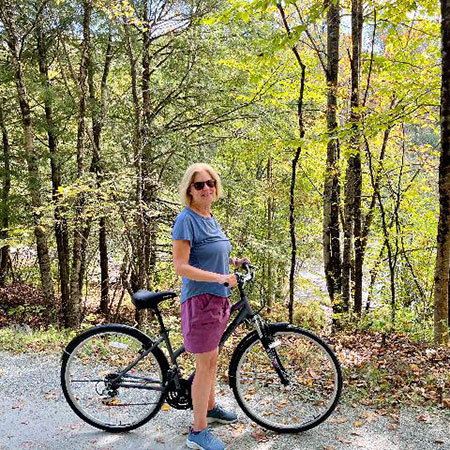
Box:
[0,98,11,287]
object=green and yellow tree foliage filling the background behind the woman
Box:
[0,0,441,339]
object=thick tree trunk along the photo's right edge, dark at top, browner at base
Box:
[434,0,450,344]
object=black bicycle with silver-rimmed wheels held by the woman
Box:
[61,264,342,433]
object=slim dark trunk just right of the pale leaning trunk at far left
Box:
[36,27,70,311]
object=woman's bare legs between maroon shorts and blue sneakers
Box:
[192,348,218,431]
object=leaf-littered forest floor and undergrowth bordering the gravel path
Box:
[0,284,450,417]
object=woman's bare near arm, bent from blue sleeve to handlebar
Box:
[172,240,236,287]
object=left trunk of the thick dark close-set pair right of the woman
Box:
[323,0,343,316]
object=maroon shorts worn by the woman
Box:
[181,294,230,353]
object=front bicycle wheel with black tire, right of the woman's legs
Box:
[229,324,342,433]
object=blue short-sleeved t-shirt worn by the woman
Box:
[172,207,231,303]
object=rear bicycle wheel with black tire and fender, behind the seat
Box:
[61,324,169,432]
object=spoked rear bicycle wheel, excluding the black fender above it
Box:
[60,332,163,430]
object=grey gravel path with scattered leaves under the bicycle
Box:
[0,352,450,450]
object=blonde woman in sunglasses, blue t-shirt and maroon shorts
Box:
[172,164,248,450]
